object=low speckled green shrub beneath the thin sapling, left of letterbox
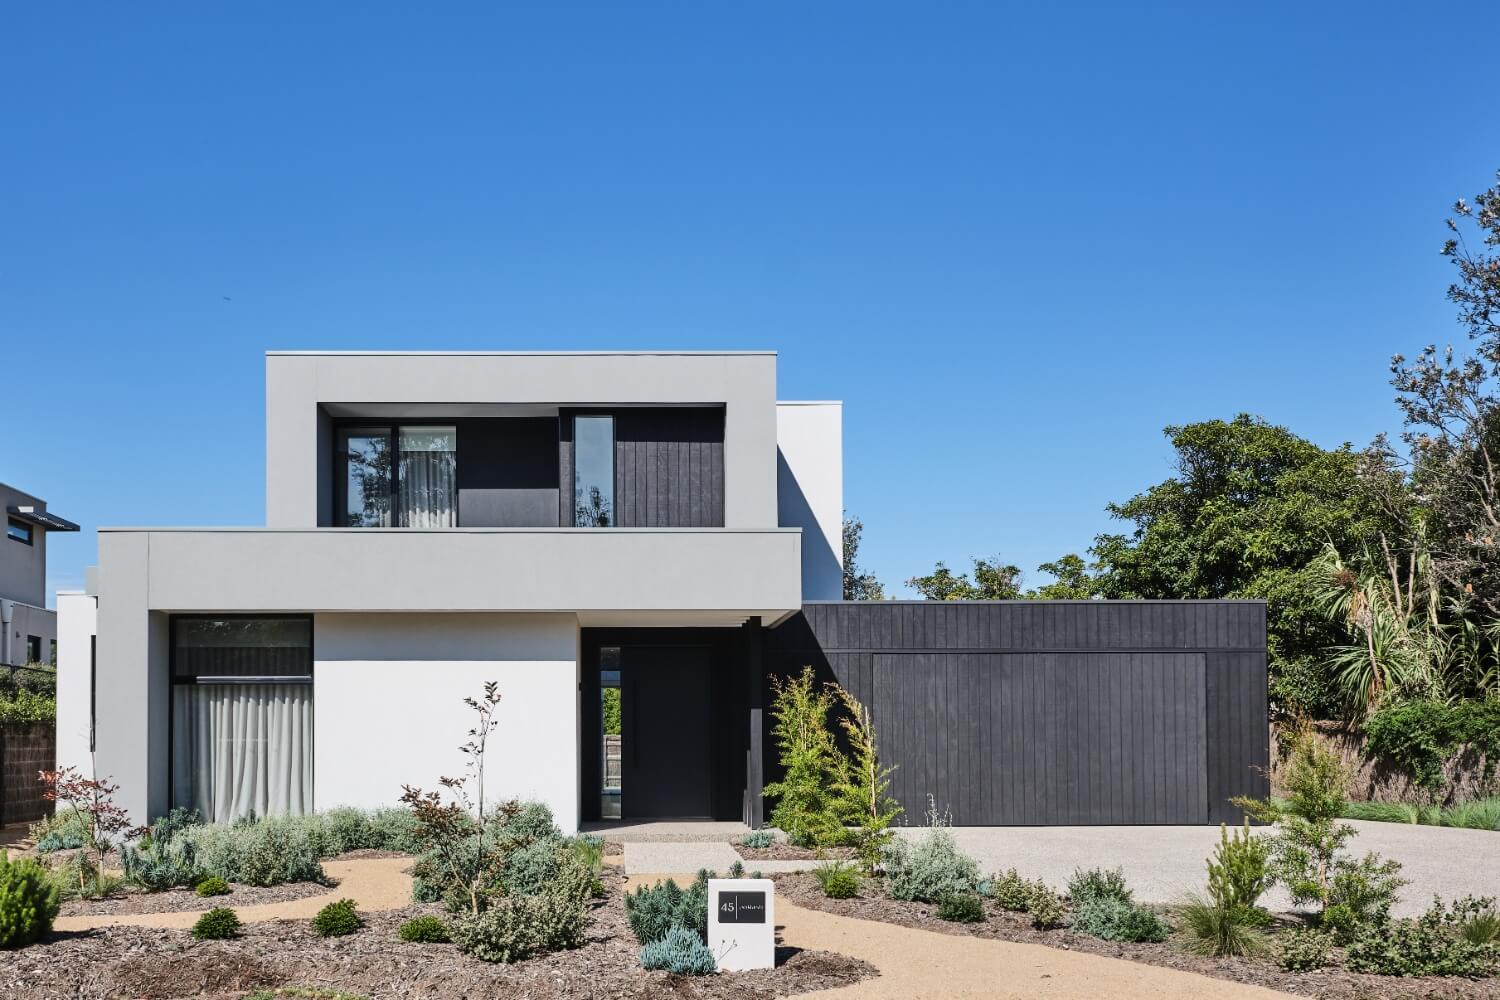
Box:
[452,865,591,963]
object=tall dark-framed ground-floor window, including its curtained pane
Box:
[171,616,312,823]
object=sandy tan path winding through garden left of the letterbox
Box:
[53,858,411,931]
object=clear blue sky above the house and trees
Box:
[0,1,1500,602]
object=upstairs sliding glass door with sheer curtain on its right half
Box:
[338,424,459,528]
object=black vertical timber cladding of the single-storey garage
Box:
[765,601,1269,826]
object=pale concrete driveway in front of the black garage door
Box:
[900,820,1500,916]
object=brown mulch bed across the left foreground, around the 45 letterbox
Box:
[0,871,876,1000]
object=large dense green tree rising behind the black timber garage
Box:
[1092,414,1385,717]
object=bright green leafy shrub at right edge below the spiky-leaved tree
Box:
[1364,699,1500,793]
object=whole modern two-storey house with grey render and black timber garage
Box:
[59,351,1268,828]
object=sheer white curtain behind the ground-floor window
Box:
[173,684,312,823]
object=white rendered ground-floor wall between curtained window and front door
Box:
[312,613,579,832]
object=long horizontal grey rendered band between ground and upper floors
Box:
[99,528,803,625]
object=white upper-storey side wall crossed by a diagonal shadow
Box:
[776,402,843,601]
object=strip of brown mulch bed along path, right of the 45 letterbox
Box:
[773,873,1500,1000]
